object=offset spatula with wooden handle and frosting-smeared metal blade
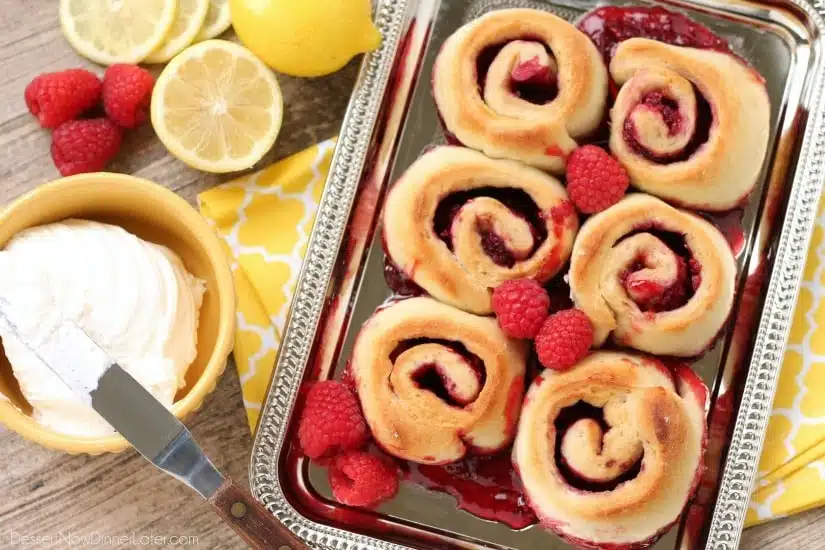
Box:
[0,298,309,550]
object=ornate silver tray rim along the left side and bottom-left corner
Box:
[249,0,409,550]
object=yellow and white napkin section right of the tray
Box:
[746,193,825,526]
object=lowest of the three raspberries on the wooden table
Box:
[52,118,122,176]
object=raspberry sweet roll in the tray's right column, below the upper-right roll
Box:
[569,194,736,357]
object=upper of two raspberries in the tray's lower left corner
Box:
[298,380,369,458]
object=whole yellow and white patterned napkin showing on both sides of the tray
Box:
[198,140,825,525]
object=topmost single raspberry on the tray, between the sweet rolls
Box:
[567,145,630,214]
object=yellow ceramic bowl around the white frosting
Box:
[0,172,235,454]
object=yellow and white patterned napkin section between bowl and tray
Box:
[198,140,335,430]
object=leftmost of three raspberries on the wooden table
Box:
[24,69,101,128]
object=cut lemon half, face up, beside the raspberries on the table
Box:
[151,40,283,173]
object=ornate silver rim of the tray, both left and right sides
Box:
[250,0,825,550]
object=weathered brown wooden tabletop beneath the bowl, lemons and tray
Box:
[0,0,825,550]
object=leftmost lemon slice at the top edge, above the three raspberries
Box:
[60,0,178,65]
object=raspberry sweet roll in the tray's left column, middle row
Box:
[383,146,579,315]
